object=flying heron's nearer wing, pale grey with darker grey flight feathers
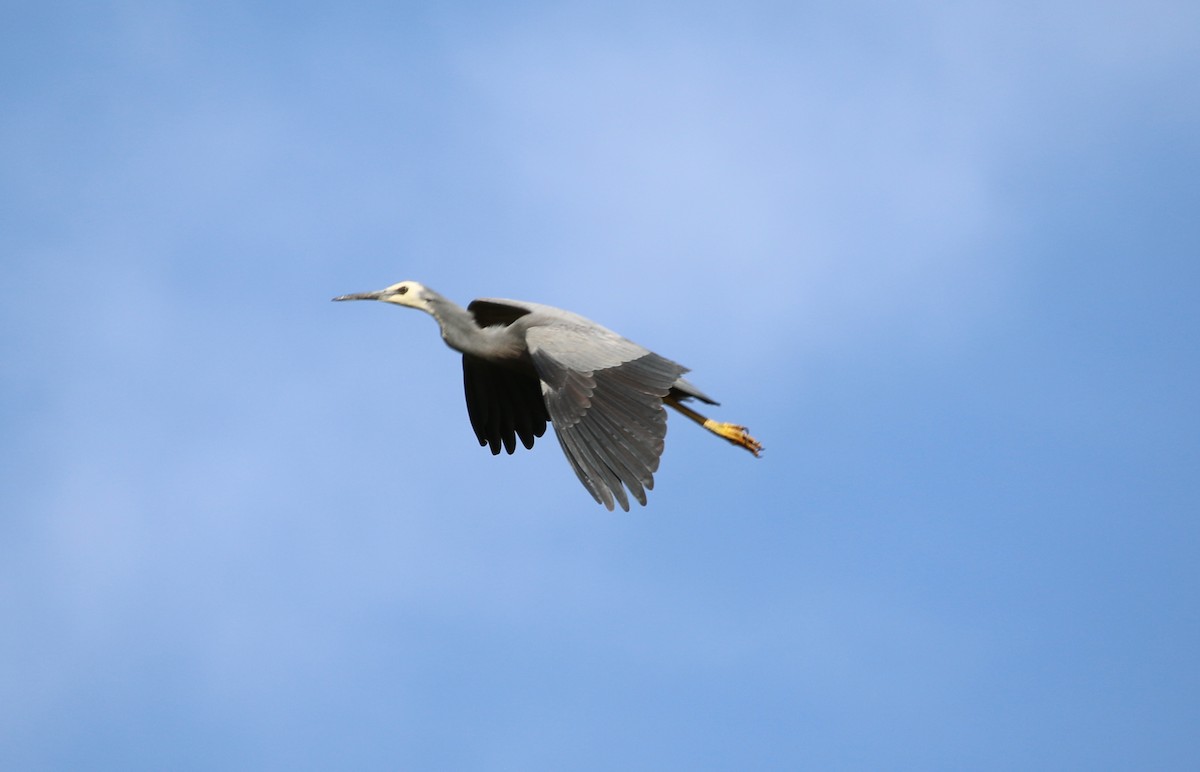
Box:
[526,321,686,511]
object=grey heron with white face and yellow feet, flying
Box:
[334,281,763,511]
